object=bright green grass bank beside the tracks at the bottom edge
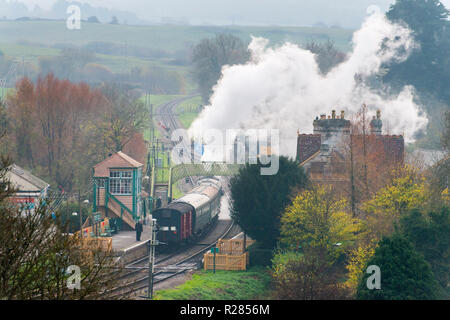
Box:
[155,267,270,300]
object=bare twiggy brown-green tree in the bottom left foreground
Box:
[0,157,120,300]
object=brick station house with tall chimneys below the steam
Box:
[296,110,404,185]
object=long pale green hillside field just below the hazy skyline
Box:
[0,21,353,53]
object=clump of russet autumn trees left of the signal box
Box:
[8,74,103,191]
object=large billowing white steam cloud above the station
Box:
[190,13,428,156]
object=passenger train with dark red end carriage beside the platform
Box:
[153,178,223,248]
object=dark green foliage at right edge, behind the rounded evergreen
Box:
[399,206,450,297]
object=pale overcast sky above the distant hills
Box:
[6,0,450,28]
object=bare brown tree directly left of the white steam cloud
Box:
[192,34,250,103]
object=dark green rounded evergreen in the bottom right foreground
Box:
[356,234,437,300]
